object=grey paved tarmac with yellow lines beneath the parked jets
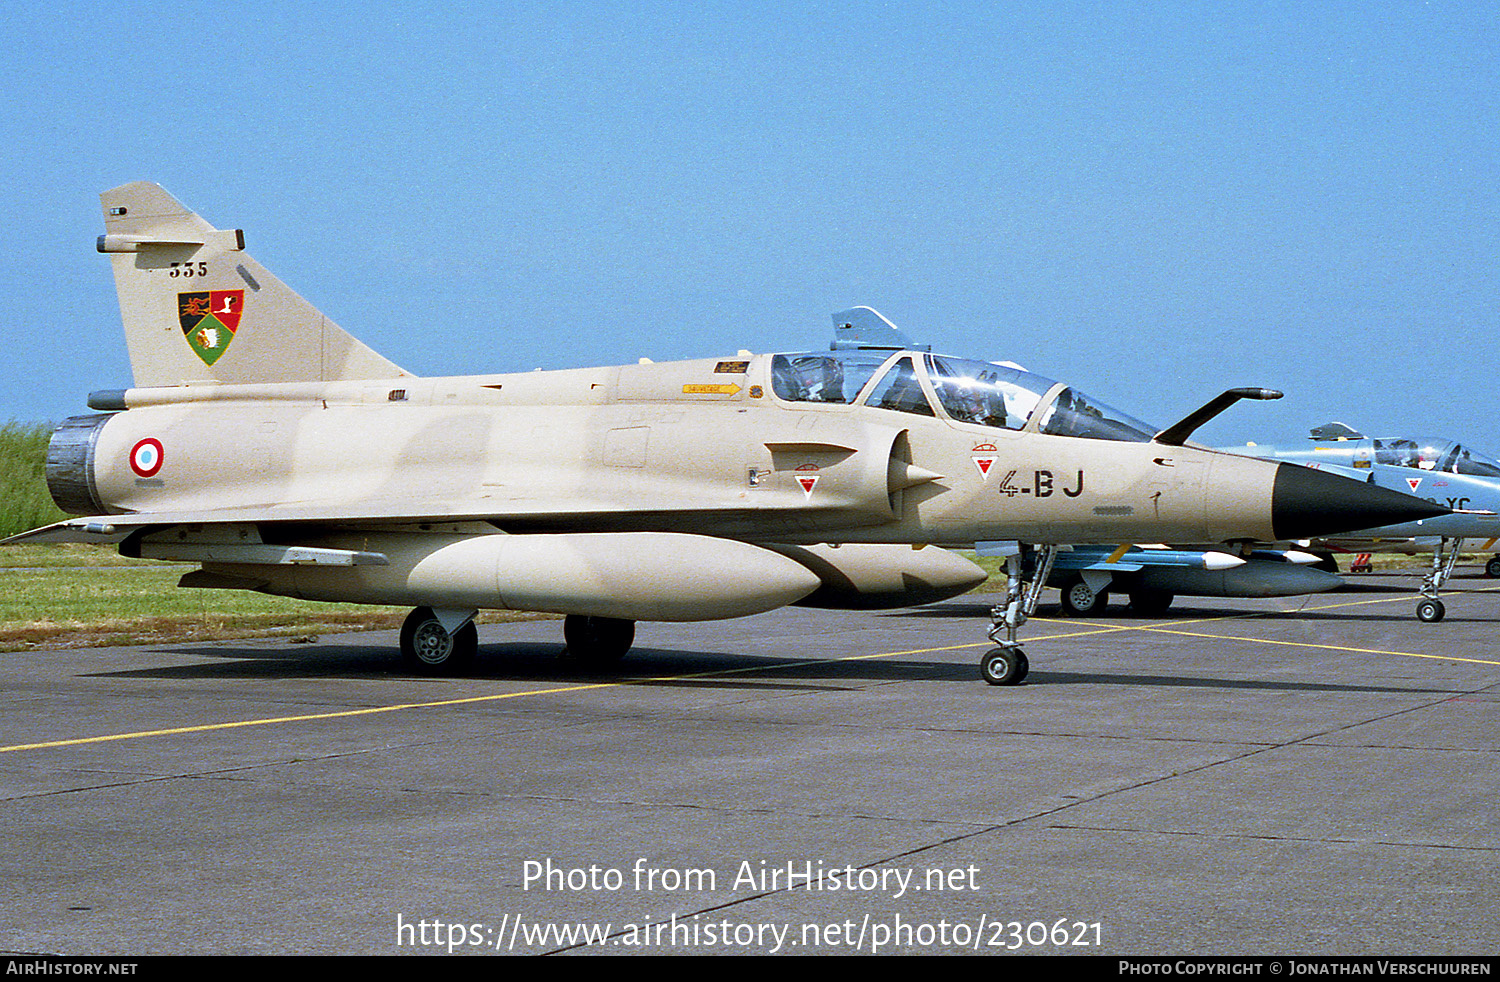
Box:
[0,574,1500,955]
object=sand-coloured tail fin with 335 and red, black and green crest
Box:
[99,181,407,387]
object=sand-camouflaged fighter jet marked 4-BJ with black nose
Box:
[9,183,1440,684]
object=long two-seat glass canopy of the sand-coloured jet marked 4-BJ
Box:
[771,351,1160,442]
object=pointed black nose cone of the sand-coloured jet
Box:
[1271,463,1449,540]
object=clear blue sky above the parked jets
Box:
[0,0,1500,453]
